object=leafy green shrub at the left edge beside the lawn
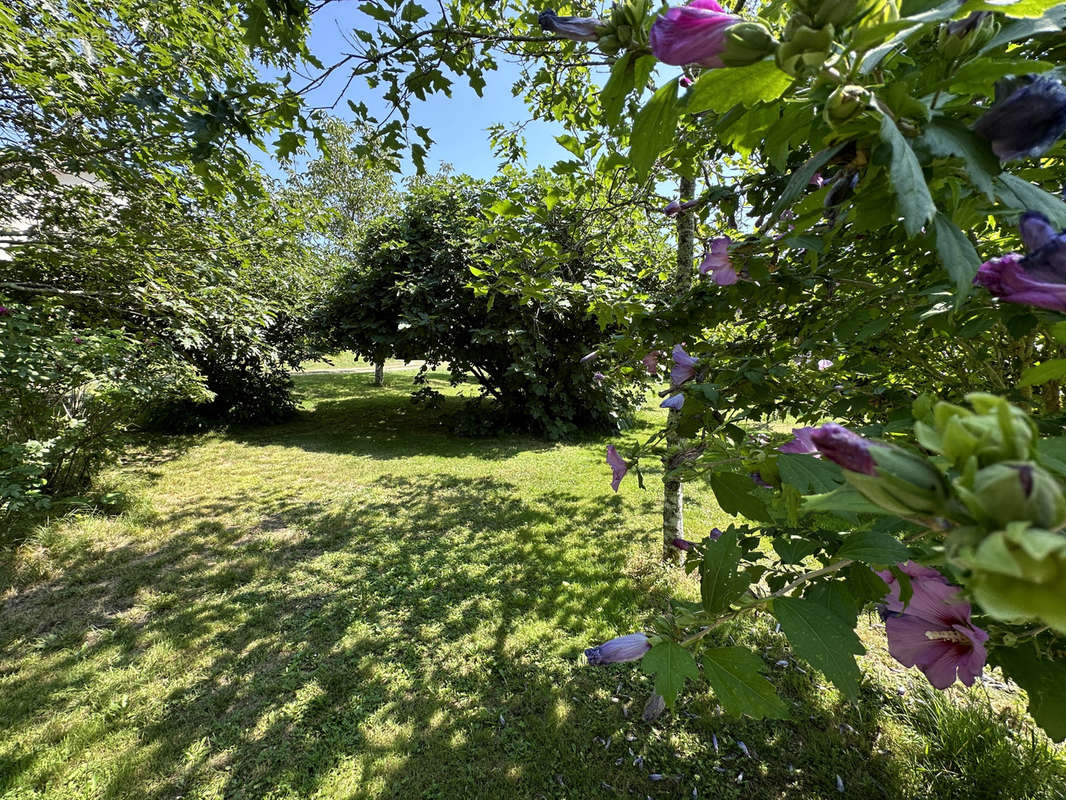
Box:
[0,299,209,515]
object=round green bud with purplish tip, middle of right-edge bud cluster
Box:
[973,461,1066,529]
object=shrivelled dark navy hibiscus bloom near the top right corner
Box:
[973,77,1066,161]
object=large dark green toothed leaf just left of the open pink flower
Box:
[771,597,866,699]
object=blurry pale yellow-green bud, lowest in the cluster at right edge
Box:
[969,523,1066,633]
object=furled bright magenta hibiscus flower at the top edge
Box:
[648,0,740,69]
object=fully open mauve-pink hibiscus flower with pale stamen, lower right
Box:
[877,561,988,689]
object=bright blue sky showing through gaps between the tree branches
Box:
[256,0,584,177]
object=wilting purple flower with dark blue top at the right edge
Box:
[973,211,1066,314]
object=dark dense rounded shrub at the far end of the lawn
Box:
[319,178,643,437]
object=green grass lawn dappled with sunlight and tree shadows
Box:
[0,372,1066,800]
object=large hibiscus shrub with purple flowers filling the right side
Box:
[567,0,1066,739]
